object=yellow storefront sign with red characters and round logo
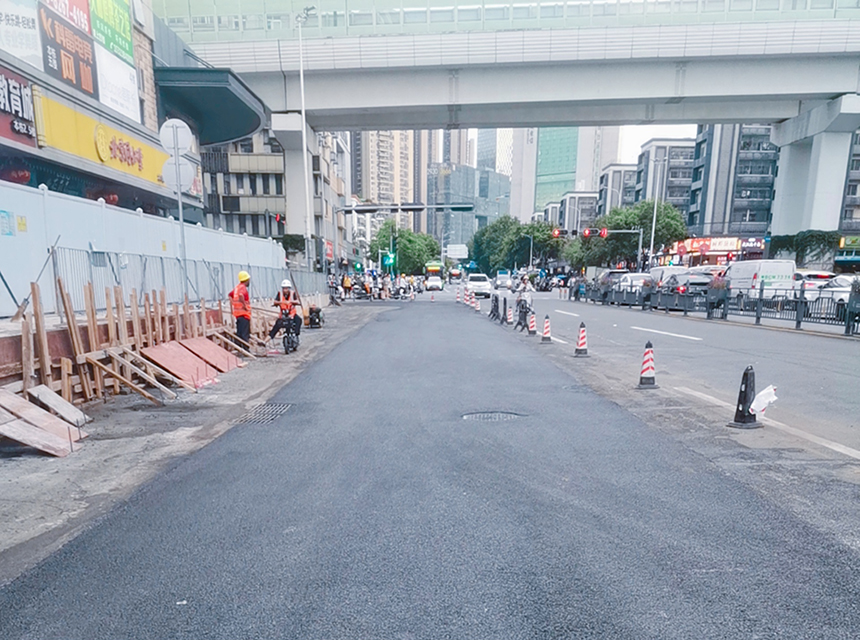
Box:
[36,96,169,185]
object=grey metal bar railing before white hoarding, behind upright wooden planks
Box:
[53,247,327,312]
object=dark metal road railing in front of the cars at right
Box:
[569,284,860,335]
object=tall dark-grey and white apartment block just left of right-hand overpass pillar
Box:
[686,124,779,236]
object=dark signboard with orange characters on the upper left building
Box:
[39,6,99,99]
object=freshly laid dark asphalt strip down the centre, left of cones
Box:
[0,296,860,640]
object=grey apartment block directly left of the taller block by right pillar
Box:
[636,138,696,219]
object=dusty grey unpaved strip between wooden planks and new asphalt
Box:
[0,303,392,585]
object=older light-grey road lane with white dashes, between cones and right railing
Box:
[500,292,860,440]
